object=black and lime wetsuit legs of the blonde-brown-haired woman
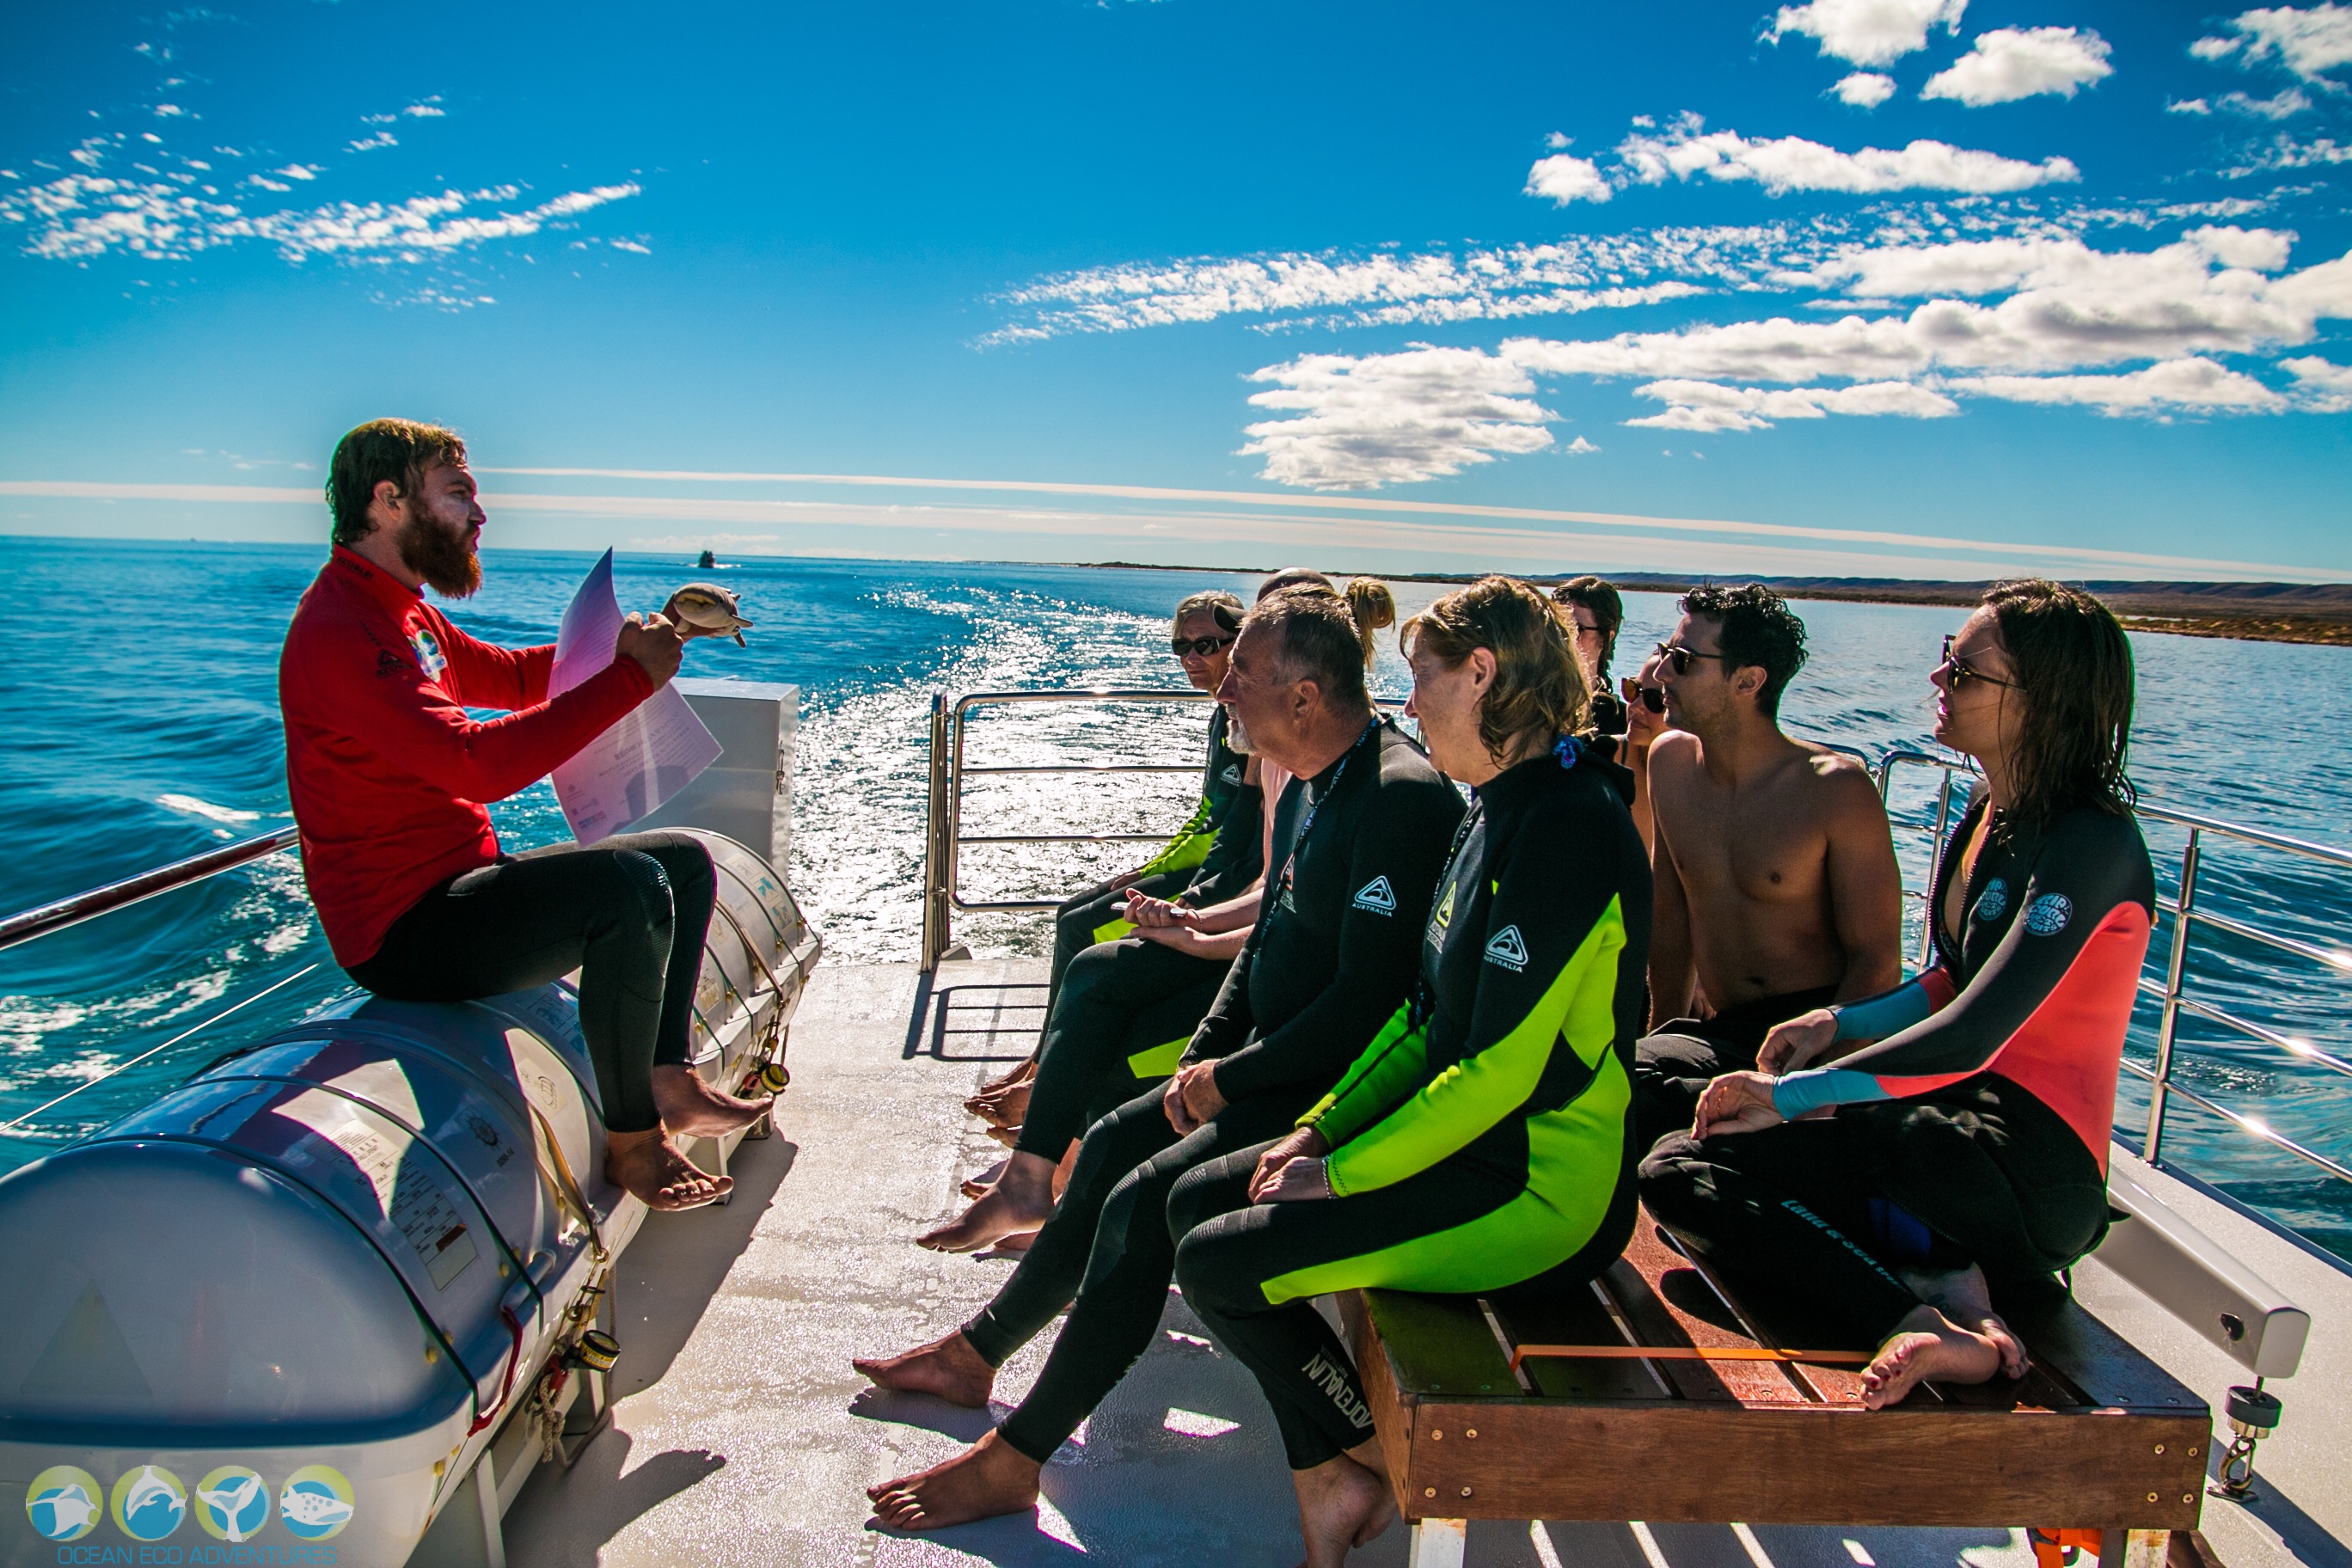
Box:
[1169,1142,1635,1469]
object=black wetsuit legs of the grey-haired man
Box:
[965,1091,1314,1465]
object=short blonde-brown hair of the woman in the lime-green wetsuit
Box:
[1397,576,1592,762]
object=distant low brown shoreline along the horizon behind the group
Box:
[1070,562,2352,646]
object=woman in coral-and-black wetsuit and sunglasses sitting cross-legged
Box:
[1642,580,2154,1406]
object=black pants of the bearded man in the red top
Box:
[346,832,717,1133]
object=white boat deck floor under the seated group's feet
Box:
[505,961,2352,1568]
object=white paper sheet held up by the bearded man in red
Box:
[548,550,720,844]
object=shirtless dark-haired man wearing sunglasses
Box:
[1635,583,1902,1149]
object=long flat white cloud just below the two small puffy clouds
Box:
[1618,115,2081,195]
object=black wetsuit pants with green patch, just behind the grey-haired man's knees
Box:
[1016,935,1233,1164]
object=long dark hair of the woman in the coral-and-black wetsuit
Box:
[1985,579,2135,828]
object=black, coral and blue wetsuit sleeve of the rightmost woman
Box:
[1773,811,2154,1117]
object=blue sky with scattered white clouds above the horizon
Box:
[0,0,2352,579]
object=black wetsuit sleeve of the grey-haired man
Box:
[1216,774,1463,1100]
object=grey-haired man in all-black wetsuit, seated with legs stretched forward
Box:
[856,590,1463,1530]
